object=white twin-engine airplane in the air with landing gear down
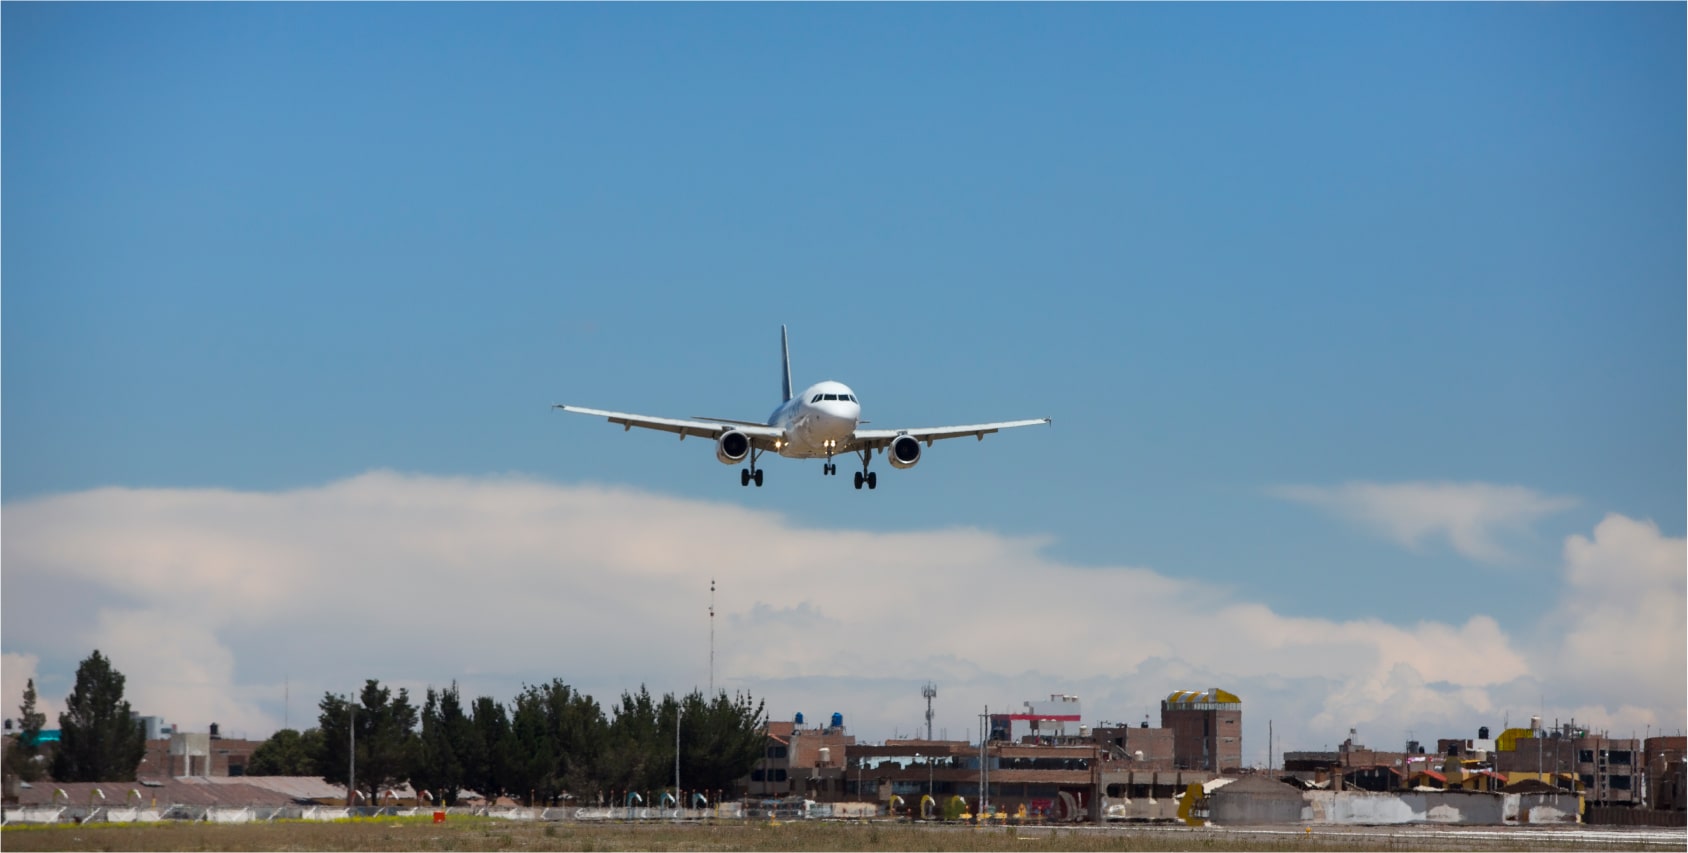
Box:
[552,326,1052,490]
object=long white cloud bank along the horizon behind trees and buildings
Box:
[0,471,1683,762]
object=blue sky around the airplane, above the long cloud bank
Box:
[0,3,1688,753]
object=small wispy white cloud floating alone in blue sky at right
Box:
[1269,483,1577,562]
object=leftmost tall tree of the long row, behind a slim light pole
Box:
[317,679,420,806]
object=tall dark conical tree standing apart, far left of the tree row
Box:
[52,649,147,782]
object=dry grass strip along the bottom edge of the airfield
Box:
[0,818,1683,853]
